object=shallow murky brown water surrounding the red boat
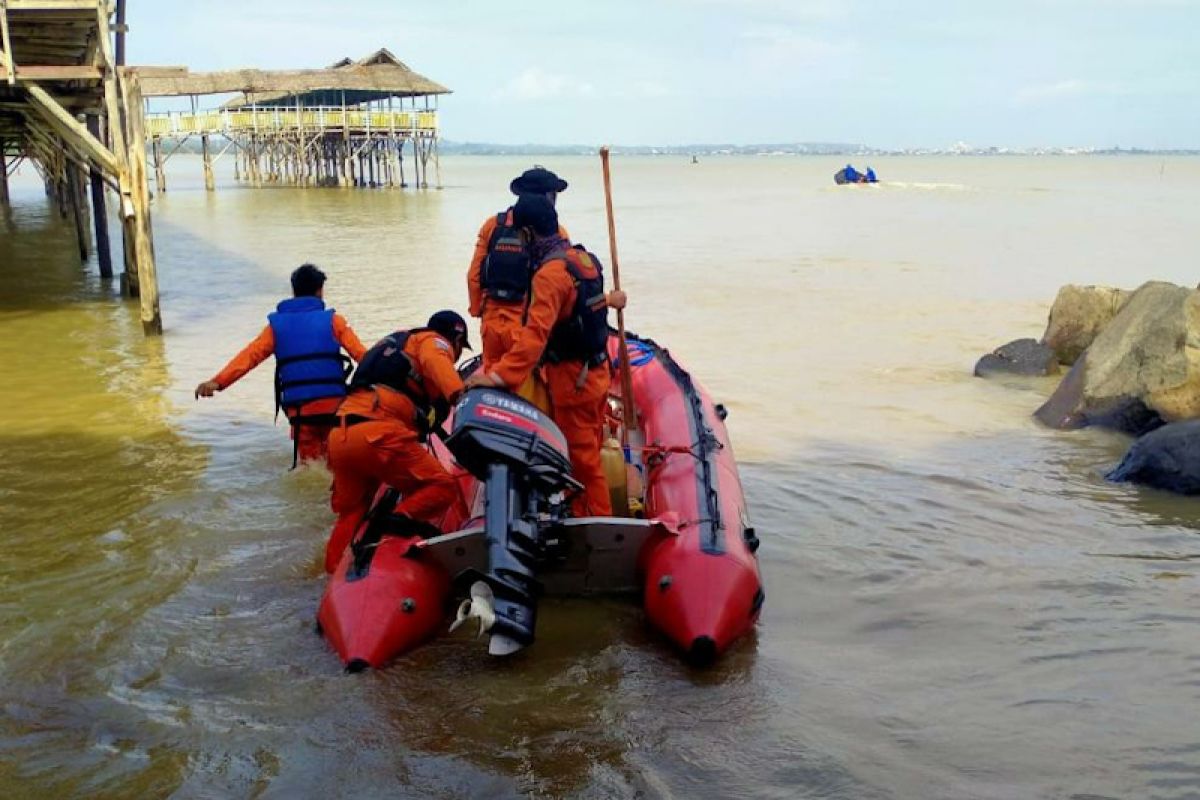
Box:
[0,156,1200,799]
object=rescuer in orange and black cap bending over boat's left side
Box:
[325,311,470,572]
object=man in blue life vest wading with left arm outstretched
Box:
[196,264,366,468]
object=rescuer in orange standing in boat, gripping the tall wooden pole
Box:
[467,194,625,517]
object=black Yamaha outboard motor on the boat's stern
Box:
[446,389,580,655]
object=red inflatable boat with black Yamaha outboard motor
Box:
[318,335,764,672]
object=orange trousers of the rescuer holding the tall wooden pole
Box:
[546,361,612,517]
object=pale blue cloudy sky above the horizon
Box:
[128,0,1200,148]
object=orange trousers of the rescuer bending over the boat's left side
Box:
[325,420,458,572]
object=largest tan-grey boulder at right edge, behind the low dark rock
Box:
[1034,282,1200,434]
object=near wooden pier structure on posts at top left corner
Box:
[0,0,162,333]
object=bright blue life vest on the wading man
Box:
[266,297,347,408]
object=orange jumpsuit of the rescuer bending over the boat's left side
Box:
[325,331,463,572]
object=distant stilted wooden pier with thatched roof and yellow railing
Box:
[142,49,450,192]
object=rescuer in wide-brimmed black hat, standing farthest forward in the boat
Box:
[467,167,569,369]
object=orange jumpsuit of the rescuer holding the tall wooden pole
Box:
[492,258,612,517]
